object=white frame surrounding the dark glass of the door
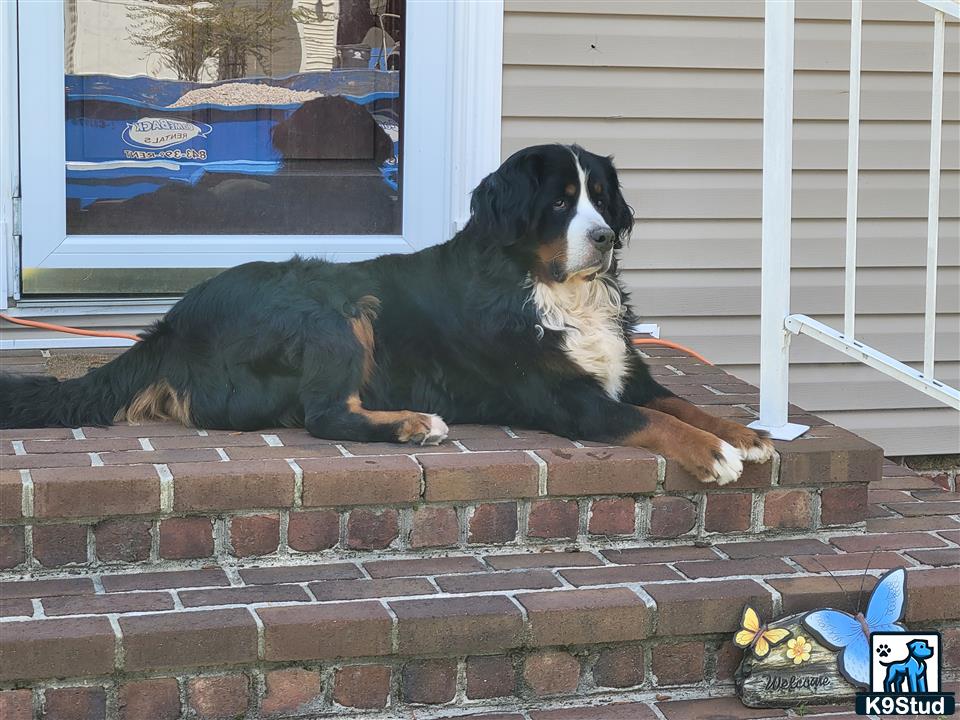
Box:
[7,0,503,290]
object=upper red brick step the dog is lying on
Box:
[0,414,882,570]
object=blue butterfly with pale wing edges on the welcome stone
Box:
[803,568,907,688]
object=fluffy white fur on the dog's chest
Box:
[531,278,627,399]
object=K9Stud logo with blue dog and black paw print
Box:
[857,631,954,716]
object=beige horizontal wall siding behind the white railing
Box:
[503,0,960,454]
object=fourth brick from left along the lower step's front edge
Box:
[390,595,523,655]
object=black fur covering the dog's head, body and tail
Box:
[0,145,671,440]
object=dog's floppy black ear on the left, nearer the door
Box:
[470,148,543,246]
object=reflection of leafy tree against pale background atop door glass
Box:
[128,0,291,82]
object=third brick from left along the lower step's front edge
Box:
[256,602,393,660]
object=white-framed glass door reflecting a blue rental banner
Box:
[19,0,450,295]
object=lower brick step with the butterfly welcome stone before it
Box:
[0,500,960,720]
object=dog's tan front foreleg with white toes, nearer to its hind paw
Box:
[620,409,743,485]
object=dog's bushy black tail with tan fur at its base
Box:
[0,323,184,428]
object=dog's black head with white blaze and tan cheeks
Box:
[470,145,633,282]
